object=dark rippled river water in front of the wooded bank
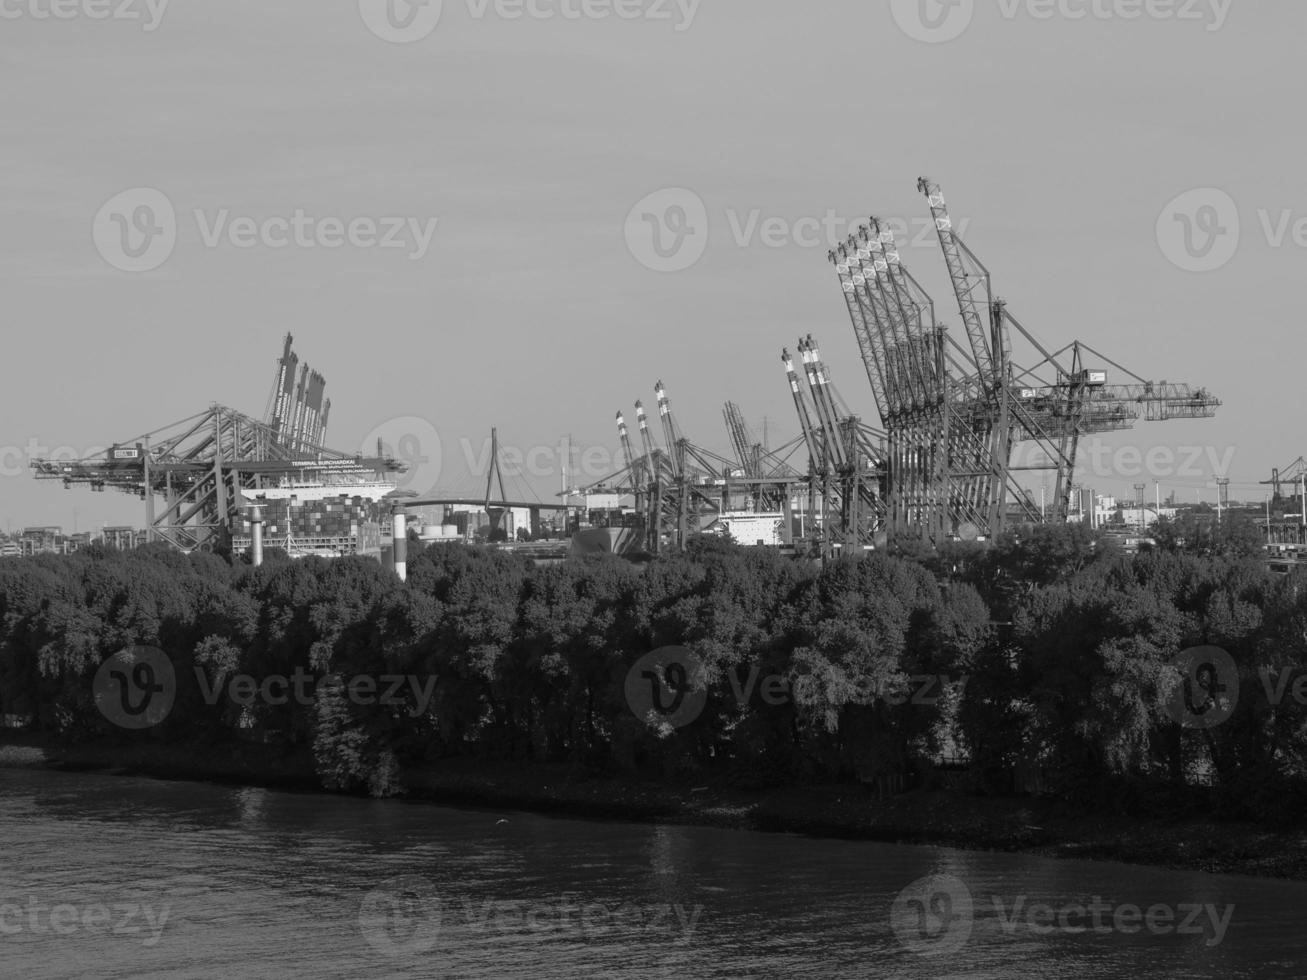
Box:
[0,771,1307,980]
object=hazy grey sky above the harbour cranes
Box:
[0,0,1307,538]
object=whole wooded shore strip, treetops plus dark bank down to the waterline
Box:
[0,520,1307,879]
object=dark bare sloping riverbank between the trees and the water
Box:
[0,733,1307,881]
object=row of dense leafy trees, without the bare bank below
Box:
[0,527,1307,819]
